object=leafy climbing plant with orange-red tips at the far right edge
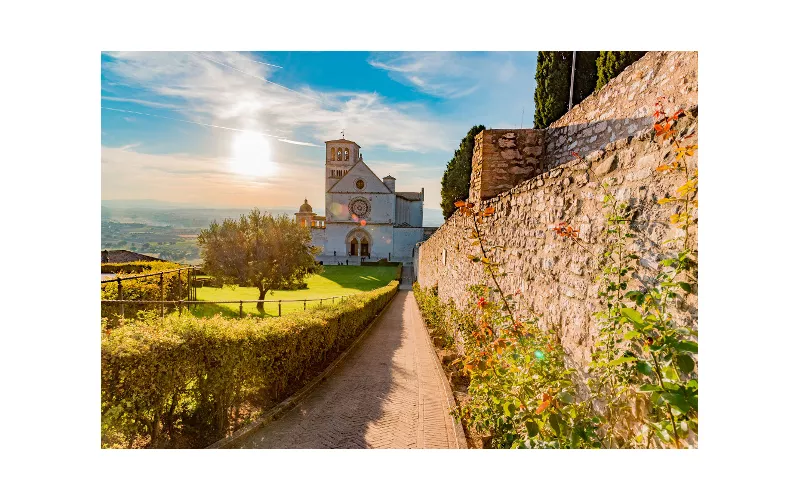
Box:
[564,98,698,447]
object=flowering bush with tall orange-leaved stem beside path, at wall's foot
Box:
[444,201,598,448]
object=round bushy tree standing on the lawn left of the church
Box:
[197,208,318,313]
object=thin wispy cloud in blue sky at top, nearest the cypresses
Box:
[369,52,516,99]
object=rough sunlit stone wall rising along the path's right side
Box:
[417,52,697,368]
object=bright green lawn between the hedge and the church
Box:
[192,266,397,317]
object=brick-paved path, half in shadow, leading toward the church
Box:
[237,291,457,448]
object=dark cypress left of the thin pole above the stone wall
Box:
[533,51,572,128]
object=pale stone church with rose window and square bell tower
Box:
[295,139,426,263]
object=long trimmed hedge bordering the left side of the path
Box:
[101,281,398,447]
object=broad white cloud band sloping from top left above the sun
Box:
[104,52,460,152]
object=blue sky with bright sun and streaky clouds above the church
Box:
[101,52,536,218]
